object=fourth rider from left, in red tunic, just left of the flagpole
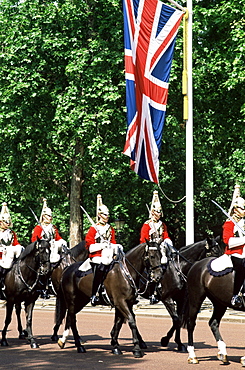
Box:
[140,190,174,304]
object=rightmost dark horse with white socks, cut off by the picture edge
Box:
[187,253,245,366]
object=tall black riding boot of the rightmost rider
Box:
[231,256,245,308]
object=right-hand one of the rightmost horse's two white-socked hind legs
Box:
[209,302,229,365]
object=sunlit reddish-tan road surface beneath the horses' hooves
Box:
[0,308,245,370]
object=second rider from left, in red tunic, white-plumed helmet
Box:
[31,198,69,299]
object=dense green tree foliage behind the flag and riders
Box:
[0,0,245,248]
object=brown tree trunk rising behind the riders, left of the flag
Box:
[70,140,84,248]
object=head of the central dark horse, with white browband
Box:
[144,240,163,282]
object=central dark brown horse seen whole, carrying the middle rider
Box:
[56,243,162,357]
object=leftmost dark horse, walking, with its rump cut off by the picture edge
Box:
[1,240,50,348]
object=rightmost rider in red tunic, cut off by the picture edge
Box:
[223,185,245,308]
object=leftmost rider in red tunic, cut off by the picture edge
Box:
[0,203,24,298]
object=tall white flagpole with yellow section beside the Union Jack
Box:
[184,0,194,245]
